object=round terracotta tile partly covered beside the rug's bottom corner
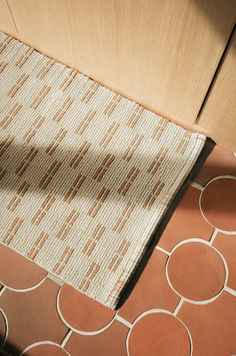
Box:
[59,284,116,332]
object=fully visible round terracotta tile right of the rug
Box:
[167,241,226,301]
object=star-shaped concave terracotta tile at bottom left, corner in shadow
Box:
[0,279,68,354]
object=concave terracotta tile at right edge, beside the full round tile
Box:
[213,232,236,290]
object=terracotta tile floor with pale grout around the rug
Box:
[0,146,236,356]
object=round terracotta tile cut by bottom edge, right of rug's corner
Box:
[128,311,190,356]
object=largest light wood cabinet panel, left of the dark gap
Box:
[2,0,236,131]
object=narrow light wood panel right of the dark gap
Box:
[199,33,236,152]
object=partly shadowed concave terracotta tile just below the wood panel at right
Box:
[194,145,236,185]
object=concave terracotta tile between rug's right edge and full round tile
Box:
[118,250,179,323]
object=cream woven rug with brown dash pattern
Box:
[0,33,205,308]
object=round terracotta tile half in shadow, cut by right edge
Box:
[200,177,236,231]
